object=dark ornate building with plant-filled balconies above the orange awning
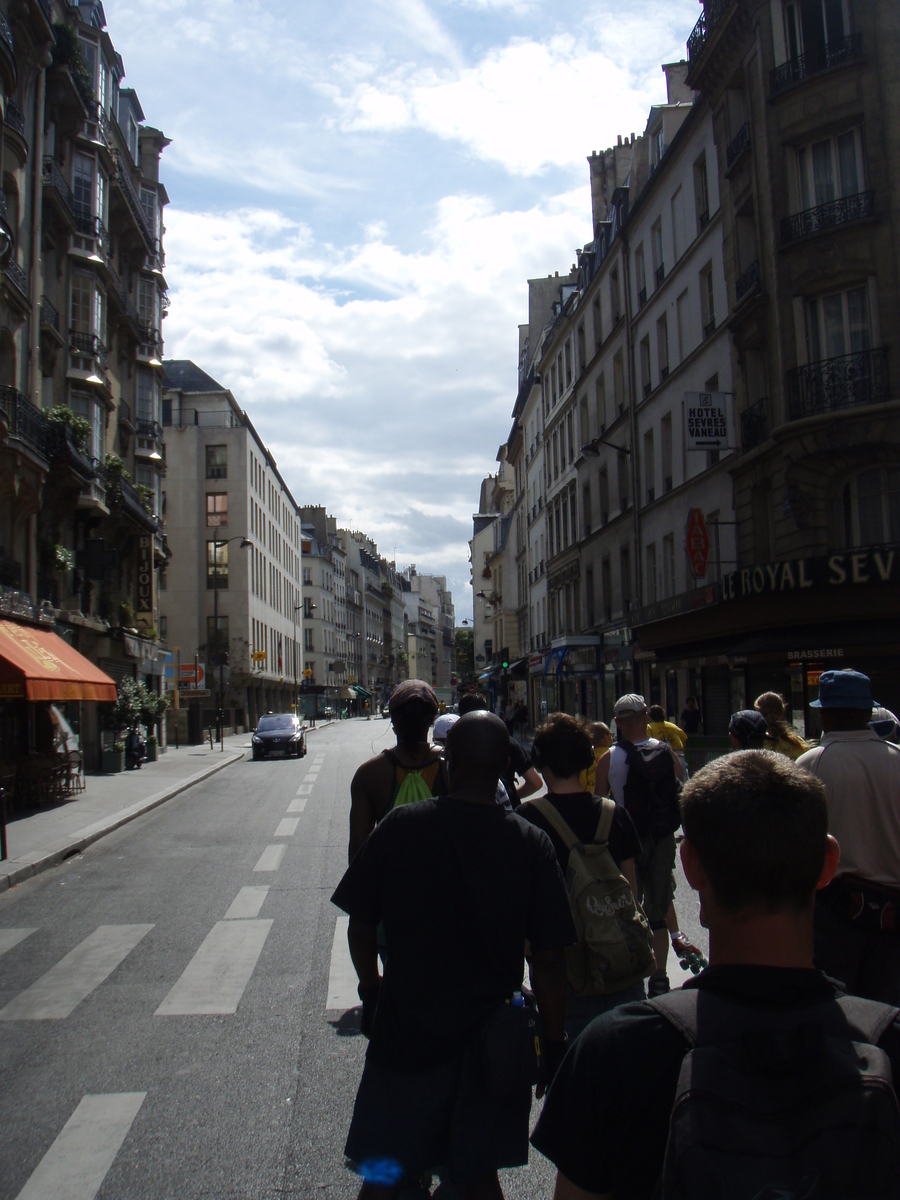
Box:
[0,0,170,767]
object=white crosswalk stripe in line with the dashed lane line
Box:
[154,920,272,1016]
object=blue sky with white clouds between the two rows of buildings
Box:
[104,0,700,622]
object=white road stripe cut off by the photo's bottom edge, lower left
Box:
[17,1092,146,1200]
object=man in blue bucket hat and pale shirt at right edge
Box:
[797,671,900,1004]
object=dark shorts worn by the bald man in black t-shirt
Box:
[344,1050,532,1187]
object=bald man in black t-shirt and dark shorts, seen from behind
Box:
[331,712,576,1200]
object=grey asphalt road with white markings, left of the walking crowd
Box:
[0,720,701,1200]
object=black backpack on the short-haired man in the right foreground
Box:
[650,988,900,1200]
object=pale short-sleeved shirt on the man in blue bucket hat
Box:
[797,730,900,888]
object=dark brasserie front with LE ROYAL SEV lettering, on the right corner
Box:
[635,546,900,738]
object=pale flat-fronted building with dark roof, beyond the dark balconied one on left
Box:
[160,360,304,728]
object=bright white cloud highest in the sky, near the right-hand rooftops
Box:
[337,35,652,175]
